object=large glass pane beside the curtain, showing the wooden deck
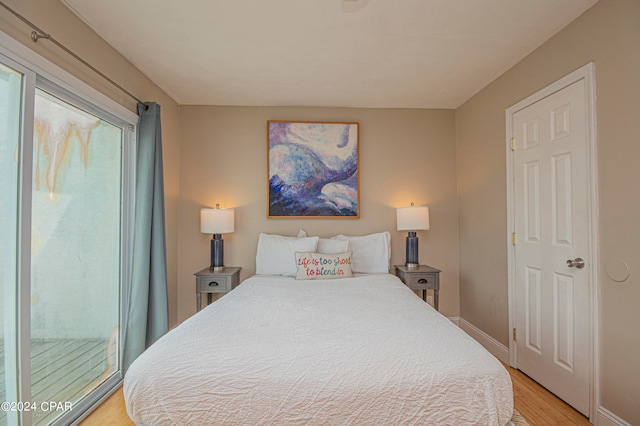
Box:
[31,90,122,424]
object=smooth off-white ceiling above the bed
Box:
[61,0,597,108]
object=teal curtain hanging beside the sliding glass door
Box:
[123,102,169,372]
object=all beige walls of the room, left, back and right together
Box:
[0,0,640,424]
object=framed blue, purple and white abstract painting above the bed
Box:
[267,120,360,218]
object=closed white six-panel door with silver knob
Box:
[512,79,593,416]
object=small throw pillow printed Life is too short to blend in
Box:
[296,252,353,280]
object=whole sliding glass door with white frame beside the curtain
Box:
[0,49,134,426]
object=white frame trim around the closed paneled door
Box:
[505,62,600,420]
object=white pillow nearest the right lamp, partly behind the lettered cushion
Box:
[333,231,391,274]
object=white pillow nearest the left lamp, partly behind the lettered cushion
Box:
[256,232,319,277]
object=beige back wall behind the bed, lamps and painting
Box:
[178,106,458,320]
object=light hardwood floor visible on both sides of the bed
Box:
[80,367,591,426]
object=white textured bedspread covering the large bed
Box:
[124,274,513,426]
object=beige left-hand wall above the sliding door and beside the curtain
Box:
[0,0,180,324]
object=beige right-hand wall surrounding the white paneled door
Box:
[456,0,640,424]
